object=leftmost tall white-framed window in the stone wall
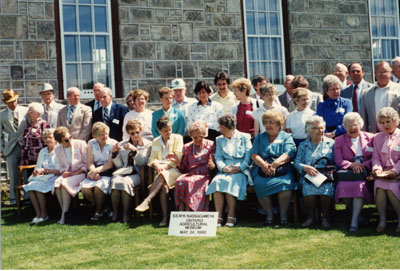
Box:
[59,0,115,98]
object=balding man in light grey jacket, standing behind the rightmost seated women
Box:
[360,61,400,133]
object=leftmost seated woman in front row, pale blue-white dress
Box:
[24,129,60,224]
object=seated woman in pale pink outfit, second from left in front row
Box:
[53,126,87,224]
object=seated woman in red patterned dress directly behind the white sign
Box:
[175,121,215,211]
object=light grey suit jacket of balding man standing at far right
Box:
[359,81,400,133]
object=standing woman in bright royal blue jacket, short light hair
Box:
[317,74,353,138]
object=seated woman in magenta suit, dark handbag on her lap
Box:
[334,112,374,232]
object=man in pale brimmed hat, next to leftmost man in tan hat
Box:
[39,83,65,128]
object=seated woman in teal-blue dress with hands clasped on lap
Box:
[251,109,297,226]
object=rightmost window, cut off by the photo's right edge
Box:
[369,0,400,67]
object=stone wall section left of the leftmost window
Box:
[0,0,57,103]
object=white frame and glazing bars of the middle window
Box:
[242,0,286,92]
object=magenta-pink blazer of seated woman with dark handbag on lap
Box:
[334,131,375,169]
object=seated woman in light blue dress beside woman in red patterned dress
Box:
[206,114,251,227]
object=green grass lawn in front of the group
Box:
[1,205,400,269]
